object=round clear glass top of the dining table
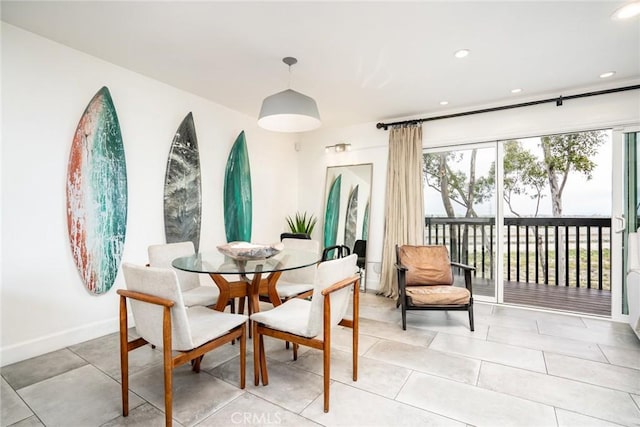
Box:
[171,249,320,274]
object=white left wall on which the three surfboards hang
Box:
[0,23,297,365]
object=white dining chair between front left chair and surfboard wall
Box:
[147,241,222,312]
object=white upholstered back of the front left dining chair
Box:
[122,263,194,350]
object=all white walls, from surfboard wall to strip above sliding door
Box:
[0,23,640,366]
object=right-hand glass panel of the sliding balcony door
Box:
[501,130,612,316]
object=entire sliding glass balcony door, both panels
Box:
[424,130,616,316]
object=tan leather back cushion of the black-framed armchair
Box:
[398,245,453,286]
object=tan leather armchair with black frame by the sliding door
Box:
[396,245,475,331]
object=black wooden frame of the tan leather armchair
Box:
[395,245,475,332]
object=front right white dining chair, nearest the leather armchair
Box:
[251,254,360,412]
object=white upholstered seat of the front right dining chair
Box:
[251,298,316,338]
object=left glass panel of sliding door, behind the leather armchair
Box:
[423,143,500,302]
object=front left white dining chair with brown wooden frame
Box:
[117,263,247,426]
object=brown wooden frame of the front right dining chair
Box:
[253,276,360,412]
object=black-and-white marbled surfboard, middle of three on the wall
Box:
[164,113,202,252]
